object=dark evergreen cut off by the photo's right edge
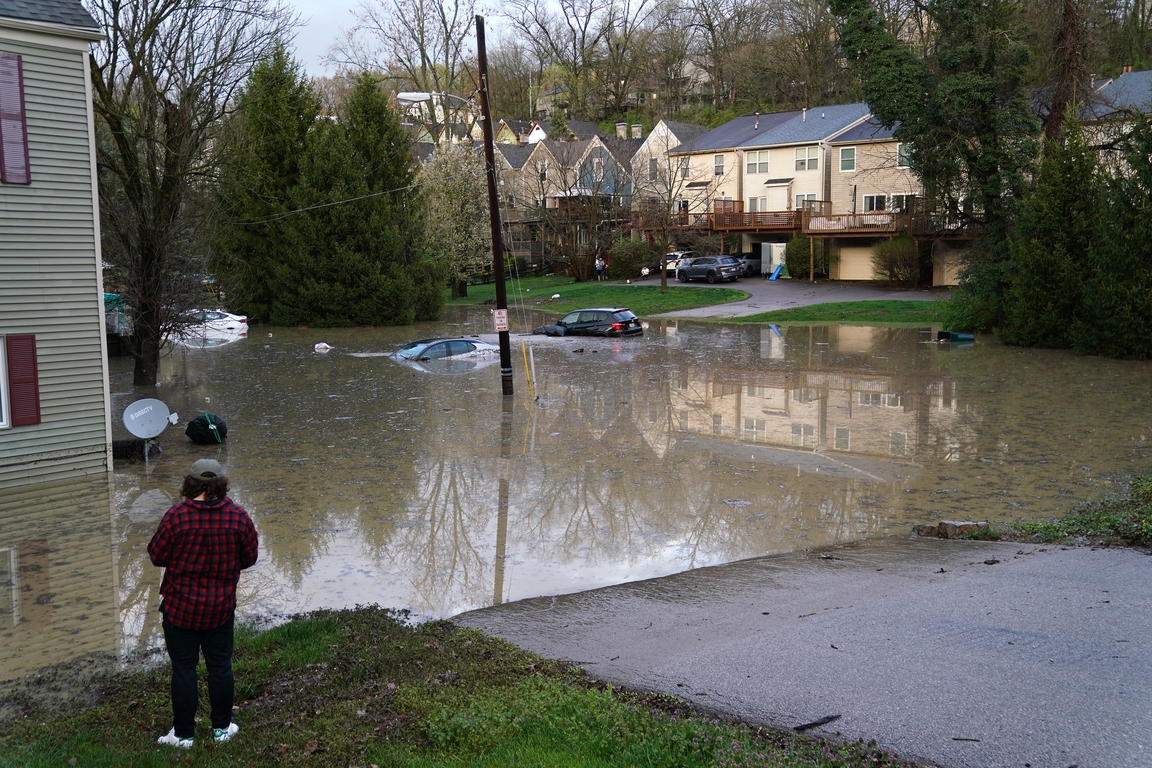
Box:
[1073,116,1152,358]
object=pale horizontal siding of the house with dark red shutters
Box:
[0,28,111,488]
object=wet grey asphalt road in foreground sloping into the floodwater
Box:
[454,540,1152,768]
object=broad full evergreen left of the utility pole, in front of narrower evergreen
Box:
[272,73,445,327]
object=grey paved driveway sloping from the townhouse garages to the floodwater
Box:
[632,276,948,318]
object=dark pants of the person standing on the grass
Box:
[164,616,236,738]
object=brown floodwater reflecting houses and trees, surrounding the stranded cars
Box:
[0,309,1152,679]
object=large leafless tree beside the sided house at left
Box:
[89,0,296,385]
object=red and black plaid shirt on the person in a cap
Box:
[147,499,259,630]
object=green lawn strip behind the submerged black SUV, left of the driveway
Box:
[448,276,748,317]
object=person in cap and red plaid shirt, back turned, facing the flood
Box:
[147,458,259,748]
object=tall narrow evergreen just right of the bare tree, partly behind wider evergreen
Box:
[214,43,320,320]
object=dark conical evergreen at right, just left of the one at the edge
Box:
[1001,120,1102,348]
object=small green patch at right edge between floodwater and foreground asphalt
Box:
[1010,474,1152,547]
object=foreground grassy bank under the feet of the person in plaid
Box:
[0,608,930,768]
